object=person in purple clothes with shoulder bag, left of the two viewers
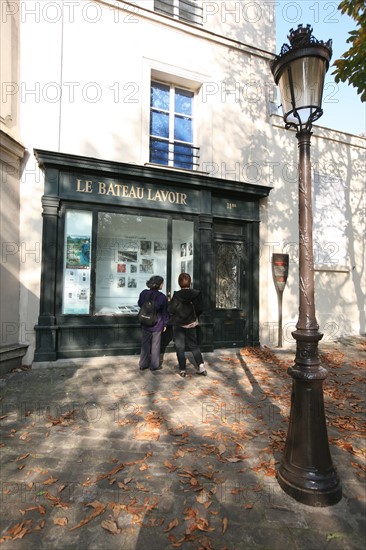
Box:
[137,275,169,371]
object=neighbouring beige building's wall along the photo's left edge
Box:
[0,0,26,372]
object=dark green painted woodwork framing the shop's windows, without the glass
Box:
[35,150,271,361]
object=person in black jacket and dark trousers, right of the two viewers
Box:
[168,273,207,377]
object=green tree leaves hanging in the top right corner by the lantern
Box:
[332,0,366,102]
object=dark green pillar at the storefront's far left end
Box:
[34,196,60,361]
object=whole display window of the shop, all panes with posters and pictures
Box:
[62,210,194,315]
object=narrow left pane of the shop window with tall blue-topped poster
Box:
[62,210,92,314]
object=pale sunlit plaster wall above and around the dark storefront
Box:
[12,0,365,361]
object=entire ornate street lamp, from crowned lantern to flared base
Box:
[271,25,342,506]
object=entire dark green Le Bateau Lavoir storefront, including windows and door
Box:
[34,150,271,361]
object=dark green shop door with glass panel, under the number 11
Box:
[214,238,246,348]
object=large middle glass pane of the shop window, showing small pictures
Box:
[95,212,168,315]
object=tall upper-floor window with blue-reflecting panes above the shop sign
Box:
[150,82,199,170]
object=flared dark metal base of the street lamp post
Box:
[277,330,342,507]
